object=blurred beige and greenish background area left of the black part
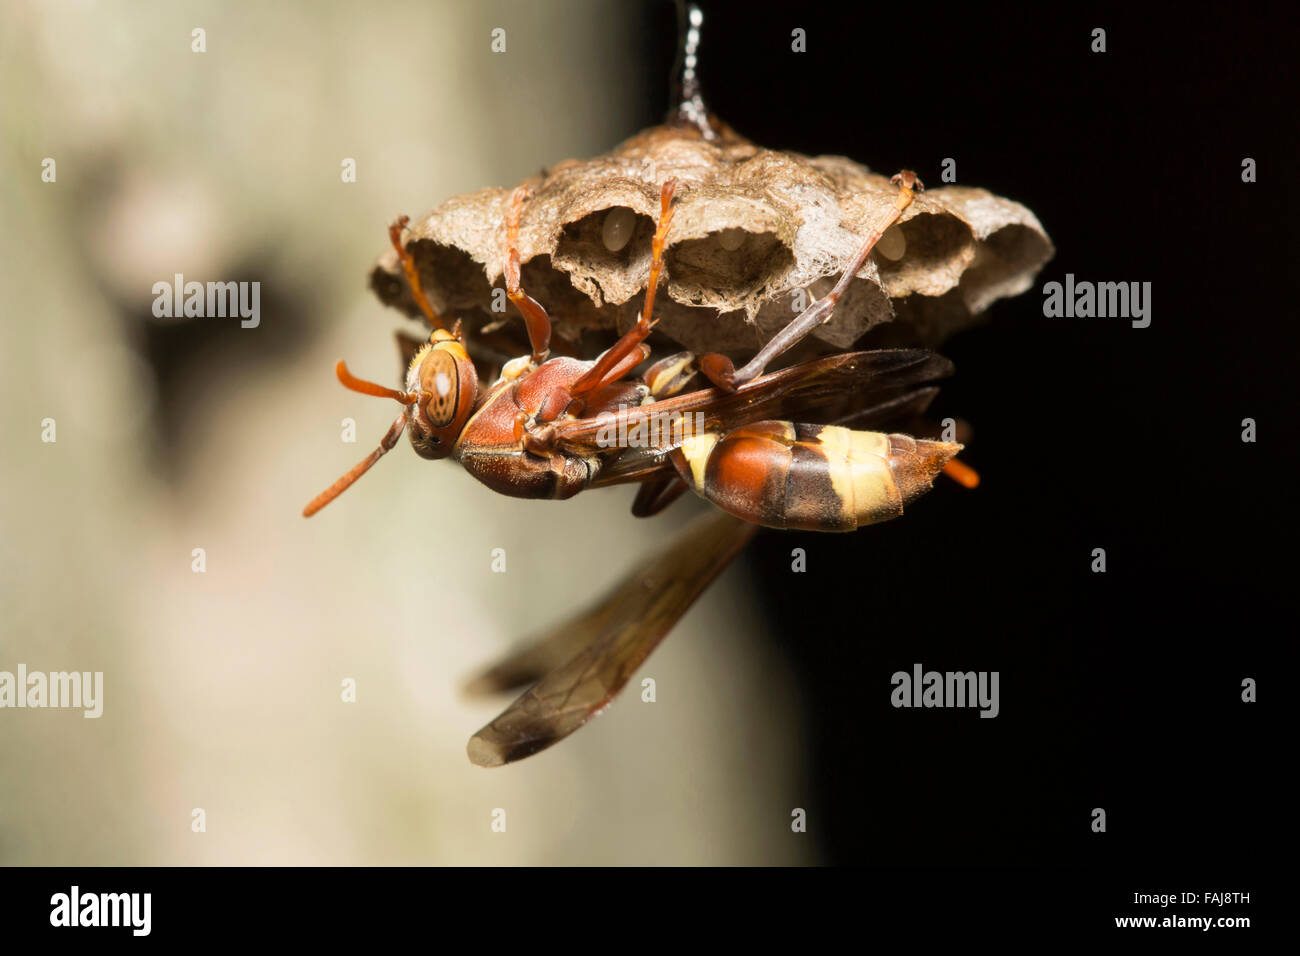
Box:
[0,0,816,864]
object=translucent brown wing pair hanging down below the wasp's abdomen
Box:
[467,512,757,767]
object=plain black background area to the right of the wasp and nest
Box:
[638,3,1297,868]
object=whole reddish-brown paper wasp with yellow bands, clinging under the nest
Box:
[303,172,972,766]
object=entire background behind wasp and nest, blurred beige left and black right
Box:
[0,0,1297,868]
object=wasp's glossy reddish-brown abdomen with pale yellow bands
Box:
[672,421,962,531]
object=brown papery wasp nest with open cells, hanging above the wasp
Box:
[371,120,1053,352]
